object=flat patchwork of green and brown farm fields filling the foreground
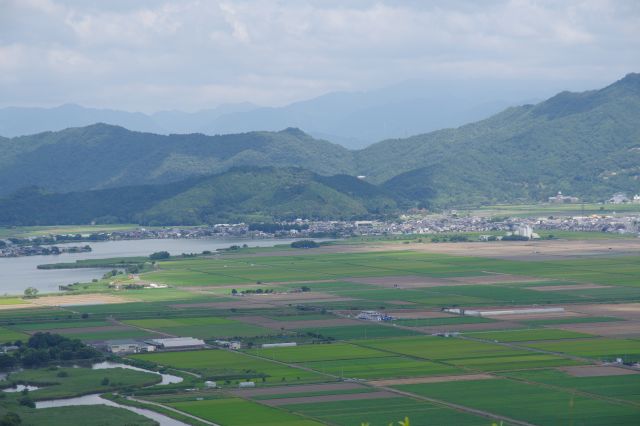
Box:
[0,237,640,426]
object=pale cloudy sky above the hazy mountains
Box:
[0,0,640,112]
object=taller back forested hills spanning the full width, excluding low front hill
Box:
[0,74,640,208]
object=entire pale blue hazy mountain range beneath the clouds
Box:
[0,81,548,149]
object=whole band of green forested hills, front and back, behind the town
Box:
[0,74,640,223]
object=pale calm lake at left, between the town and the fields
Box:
[0,238,295,295]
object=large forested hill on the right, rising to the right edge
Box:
[356,74,640,206]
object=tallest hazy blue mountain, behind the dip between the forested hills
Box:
[204,81,556,149]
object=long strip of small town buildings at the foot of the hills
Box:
[0,203,640,257]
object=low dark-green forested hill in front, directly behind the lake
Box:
[0,167,398,226]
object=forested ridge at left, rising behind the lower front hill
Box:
[0,124,354,195]
